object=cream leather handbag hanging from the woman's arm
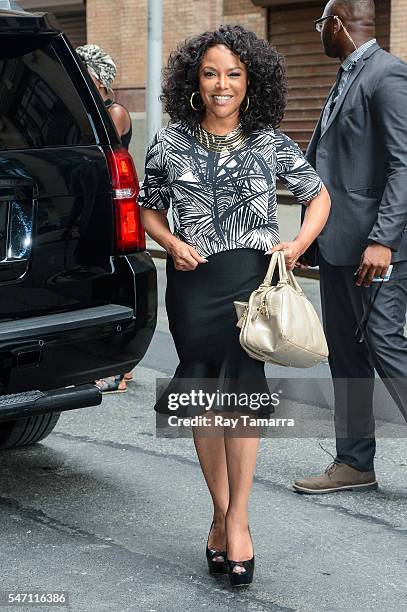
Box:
[234,251,328,368]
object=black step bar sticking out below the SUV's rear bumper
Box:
[0,384,102,423]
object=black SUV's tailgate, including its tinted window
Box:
[0,36,113,319]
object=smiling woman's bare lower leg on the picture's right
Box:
[225,418,259,572]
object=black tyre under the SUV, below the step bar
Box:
[0,412,60,449]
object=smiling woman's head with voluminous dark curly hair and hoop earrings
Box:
[161,26,287,134]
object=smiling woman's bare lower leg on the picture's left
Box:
[192,413,229,561]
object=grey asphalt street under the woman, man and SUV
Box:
[0,261,407,612]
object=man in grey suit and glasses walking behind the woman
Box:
[294,0,407,494]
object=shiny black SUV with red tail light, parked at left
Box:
[0,2,157,449]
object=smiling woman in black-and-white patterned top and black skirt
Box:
[139,26,330,586]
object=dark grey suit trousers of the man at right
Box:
[319,254,407,471]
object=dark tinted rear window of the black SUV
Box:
[0,37,95,150]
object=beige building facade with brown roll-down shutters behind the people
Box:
[19,0,407,155]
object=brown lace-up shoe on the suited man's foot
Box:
[293,461,378,495]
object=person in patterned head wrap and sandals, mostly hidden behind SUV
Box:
[76,45,133,394]
